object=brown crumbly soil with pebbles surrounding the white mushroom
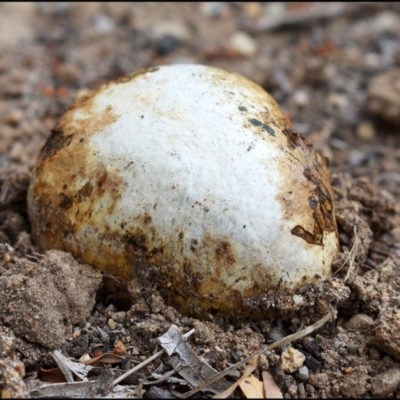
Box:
[0,2,400,398]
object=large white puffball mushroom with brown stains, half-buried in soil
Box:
[28,65,338,315]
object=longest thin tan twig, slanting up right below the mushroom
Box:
[181,313,332,399]
